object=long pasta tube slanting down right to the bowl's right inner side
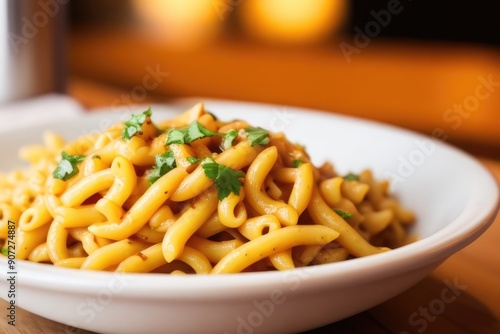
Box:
[307,186,389,257]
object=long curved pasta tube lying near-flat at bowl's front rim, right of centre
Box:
[212,225,339,274]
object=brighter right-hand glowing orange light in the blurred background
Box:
[239,0,347,44]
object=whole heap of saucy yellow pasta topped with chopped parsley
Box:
[0,103,415,274]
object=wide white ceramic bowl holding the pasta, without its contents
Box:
[0,101,499,333]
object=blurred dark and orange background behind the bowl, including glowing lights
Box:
[3,0,500,159]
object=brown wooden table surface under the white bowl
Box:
[0,83,500,334]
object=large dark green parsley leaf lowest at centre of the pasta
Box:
[201,158,245,200]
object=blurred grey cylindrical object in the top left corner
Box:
[0,0,68,103]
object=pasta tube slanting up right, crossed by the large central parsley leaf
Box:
[172,141,258,202]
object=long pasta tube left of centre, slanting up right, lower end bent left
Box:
[88,168,187,240]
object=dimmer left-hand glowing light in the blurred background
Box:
[133,0,223,47]
